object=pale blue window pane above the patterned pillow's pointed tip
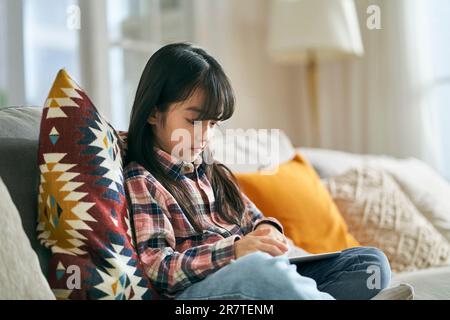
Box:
[23,0,80,106]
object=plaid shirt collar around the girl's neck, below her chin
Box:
[155,147,205,180]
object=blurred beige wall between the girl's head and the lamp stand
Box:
[192,0,307,145]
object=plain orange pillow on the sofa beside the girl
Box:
[236,154,360,253]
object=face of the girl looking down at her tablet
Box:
[148,89,216,162]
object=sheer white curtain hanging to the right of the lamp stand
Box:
[310,0,439,169]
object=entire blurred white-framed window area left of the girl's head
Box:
[0,0,195,130]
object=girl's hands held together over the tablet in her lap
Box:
[234,228,288,259]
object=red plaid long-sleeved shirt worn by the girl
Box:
[124,149,283,298]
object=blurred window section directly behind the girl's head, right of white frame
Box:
[106,0,194,129]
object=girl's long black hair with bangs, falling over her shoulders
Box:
[125,43,244,232]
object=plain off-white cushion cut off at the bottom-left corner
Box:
[0,178,55,300]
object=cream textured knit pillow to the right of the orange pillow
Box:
[323,166,450,272]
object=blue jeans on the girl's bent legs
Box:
[176,247,391,300]
